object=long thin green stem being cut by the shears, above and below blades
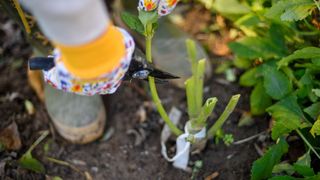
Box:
[146,23,183,136]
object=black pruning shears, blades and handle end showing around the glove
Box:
[29,48,179,83]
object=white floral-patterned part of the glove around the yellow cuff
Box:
[43,25,135,96]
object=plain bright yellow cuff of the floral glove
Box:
[56,25,125,80]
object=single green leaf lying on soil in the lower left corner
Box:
[19,151,45,173]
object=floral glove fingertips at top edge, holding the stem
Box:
[138,0,179,16]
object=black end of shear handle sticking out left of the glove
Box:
[29,57,55,71]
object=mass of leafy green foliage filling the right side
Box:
[194,0,320,179]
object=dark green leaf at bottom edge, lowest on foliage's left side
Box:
[251,138,289,180]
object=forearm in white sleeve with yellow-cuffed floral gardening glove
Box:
[20,0,135,95]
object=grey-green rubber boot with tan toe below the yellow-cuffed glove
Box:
[45,85,106,144]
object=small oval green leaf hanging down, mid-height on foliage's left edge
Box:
[250,82,272,115]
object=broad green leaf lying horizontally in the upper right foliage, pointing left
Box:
[228,37,283,59]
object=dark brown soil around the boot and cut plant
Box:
[0,7,269,180]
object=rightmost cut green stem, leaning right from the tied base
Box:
[207,94,240,137]
